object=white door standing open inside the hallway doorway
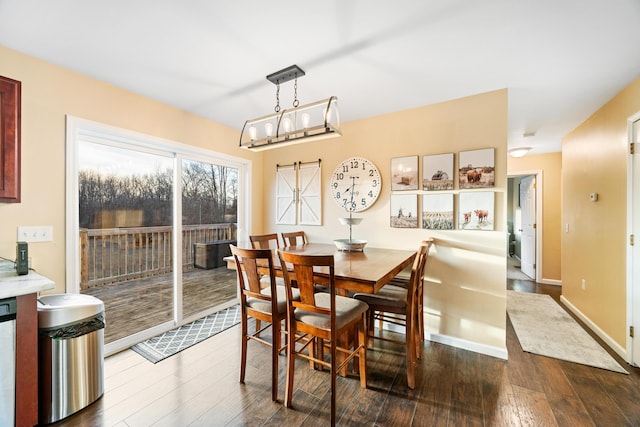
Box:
[518,175,536,279]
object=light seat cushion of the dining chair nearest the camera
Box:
[294,292,369,329]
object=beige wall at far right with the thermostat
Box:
[562,74,640,347]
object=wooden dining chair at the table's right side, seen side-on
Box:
[353,239,433,389]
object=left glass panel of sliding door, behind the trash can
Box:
[78,141,175,343]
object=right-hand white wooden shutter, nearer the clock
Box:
[298,162,322,225]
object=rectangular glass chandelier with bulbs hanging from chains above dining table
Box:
[240,65,342,151]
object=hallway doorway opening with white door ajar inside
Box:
[507,171,542,282]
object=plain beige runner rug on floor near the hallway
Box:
[507,291,628,374]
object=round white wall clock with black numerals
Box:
[331,157,382,212]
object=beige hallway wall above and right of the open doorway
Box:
[507,153,562,283]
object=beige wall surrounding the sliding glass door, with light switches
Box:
[0,46,262,292]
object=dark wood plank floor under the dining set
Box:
[59,281,640,427]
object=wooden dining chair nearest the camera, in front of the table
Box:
[278,250,368,425]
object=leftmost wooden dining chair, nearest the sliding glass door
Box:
[229,245,299,401]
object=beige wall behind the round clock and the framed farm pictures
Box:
[262,90,507,353]
